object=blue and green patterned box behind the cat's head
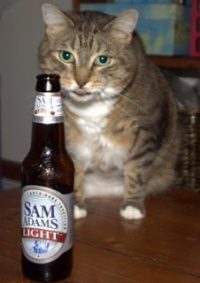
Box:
[81,3,191,55]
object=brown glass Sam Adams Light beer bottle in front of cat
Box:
[21,74,74,282]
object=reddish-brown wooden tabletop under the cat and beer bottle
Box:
[0,190,200,283]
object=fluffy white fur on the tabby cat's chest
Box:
[65,101,127,171]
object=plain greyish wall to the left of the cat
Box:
[0,0,72,162]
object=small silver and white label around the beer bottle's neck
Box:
[33,92,63,124]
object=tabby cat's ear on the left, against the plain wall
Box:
[42,3,74,36]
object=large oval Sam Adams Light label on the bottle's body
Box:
[21,186,74,264]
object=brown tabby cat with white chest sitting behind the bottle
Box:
[39,3,179,219]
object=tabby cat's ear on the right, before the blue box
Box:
[104,9,139,43]
